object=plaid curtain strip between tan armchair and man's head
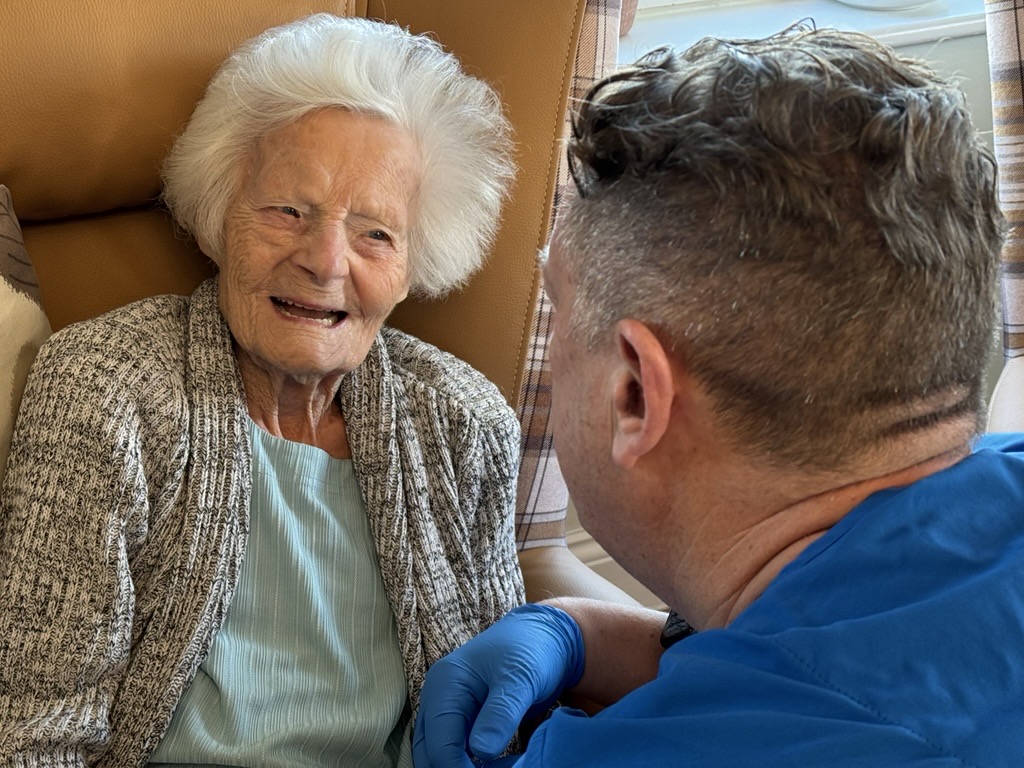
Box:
[516,0,622,549]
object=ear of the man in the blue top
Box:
[611,319,675,468]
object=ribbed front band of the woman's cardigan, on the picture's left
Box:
[111,281,251,766]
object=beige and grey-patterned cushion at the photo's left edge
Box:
[0,184,50,478]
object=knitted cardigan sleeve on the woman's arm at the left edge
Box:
[0,317,180,766]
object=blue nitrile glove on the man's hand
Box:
[413,603,584,768]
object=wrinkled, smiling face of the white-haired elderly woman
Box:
[219,110,420,382]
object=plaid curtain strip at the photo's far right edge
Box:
[985,0,1024,358]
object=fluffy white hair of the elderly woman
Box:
[163,13,513,296]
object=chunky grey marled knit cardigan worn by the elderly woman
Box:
[0,279,523,768]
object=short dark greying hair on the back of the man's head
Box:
[559,28,1004,470]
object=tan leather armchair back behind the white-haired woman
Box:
[0,0,586,404]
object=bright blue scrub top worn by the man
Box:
[517,435,1024,768]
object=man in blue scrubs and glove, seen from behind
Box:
[415,28,1024,768]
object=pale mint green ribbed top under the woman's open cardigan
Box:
[151,421,412,768]
